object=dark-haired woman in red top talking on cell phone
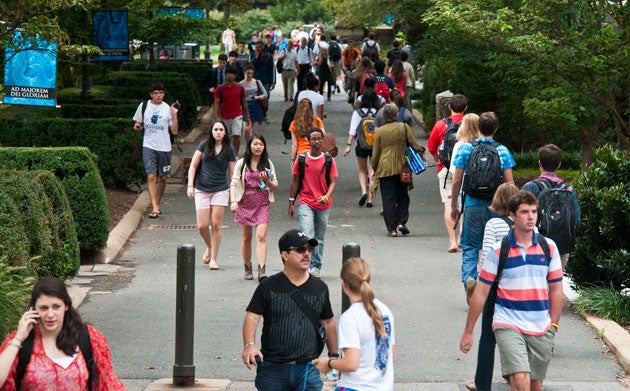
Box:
[0,277,125,391]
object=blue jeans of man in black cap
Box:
[255,361,324,391]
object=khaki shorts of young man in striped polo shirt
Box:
[494,326,556,380]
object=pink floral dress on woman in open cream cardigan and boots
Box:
[234,170,271,226]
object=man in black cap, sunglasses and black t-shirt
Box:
[242,229,339,391]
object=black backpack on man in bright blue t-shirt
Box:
[462,140,503,200]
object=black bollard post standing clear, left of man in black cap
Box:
[173,244,195,386]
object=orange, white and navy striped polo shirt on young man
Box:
[479,231,562,335]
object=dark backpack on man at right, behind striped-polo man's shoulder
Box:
[533,178,577,254]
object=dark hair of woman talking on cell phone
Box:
[31,277,83,356]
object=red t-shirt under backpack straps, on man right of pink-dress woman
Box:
[291,152,338,210]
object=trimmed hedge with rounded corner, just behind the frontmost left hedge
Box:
[0,147,108,253]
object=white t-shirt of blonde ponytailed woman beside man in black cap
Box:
[337,299,396,391]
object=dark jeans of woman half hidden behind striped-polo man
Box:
[475,300,497,391]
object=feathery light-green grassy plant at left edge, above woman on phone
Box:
[0,264,35,338]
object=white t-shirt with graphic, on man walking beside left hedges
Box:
[133,102,173,152]
